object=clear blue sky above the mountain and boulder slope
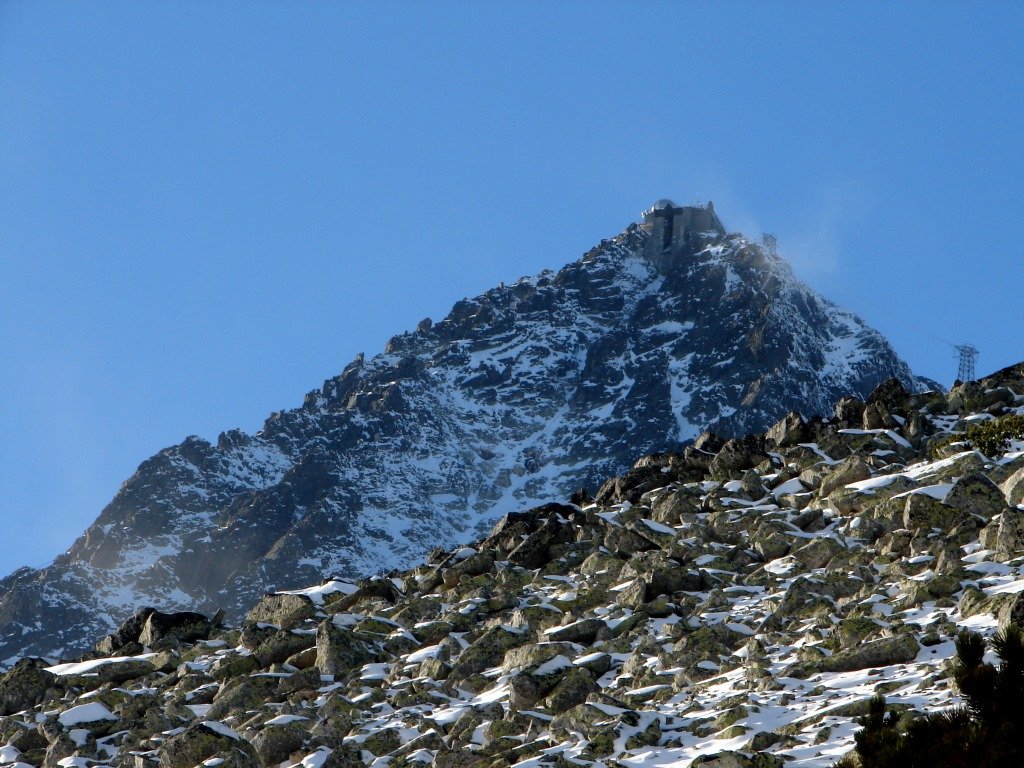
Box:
[0,0,1024,572]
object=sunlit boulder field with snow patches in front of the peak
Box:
[0,365,1024,768]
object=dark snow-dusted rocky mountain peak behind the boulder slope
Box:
[0,201,921,659]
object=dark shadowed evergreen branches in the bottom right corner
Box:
[836,625,1024,768]
